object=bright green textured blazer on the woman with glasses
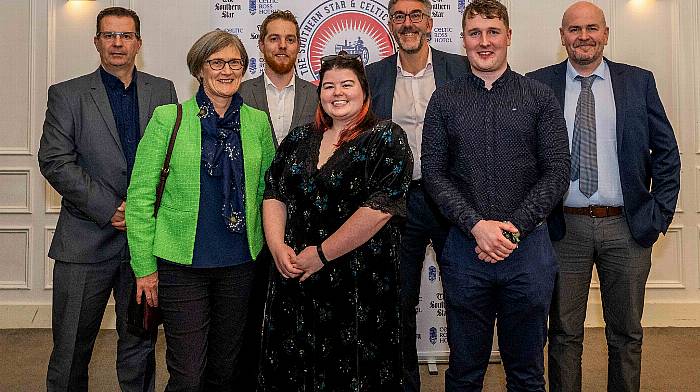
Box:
[126,97,275,277]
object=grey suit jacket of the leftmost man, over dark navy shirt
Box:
[38,69,177,263]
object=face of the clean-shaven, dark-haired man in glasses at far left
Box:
[93,15,141,74]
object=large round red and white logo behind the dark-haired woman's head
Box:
[297,0,394,80]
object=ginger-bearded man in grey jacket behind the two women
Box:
[240,10,318,146]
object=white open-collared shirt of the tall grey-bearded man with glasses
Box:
[391,46,435,180]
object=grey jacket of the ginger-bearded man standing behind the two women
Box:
[238,75,318,148]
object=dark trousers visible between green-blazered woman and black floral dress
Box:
[233,246,275,392]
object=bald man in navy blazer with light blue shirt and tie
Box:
[528,2,680,391]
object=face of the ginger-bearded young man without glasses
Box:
[258,19,299,75]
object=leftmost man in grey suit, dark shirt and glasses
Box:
[39,7,177,391]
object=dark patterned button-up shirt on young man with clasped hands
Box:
[421,68,570,235]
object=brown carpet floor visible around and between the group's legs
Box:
[0,328,700,392]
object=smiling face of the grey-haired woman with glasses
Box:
[199,45,245,101]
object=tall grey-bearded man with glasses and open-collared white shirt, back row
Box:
[367,0,469,391]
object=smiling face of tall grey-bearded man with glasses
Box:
[389,0,433,54]
